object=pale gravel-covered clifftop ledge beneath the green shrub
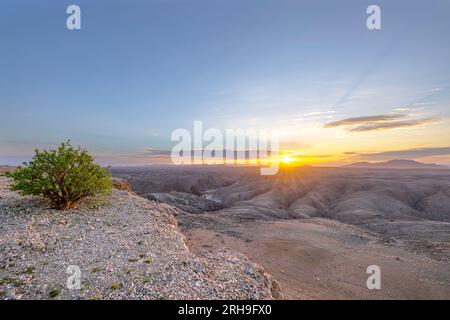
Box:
[0,177,279,299]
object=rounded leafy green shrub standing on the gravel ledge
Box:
[6,141,112,209]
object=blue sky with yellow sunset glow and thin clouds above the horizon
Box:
[0,0,450,165]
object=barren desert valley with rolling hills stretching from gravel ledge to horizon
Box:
[113,167,450,299]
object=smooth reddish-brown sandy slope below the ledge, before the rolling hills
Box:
[184,218,450,299]
